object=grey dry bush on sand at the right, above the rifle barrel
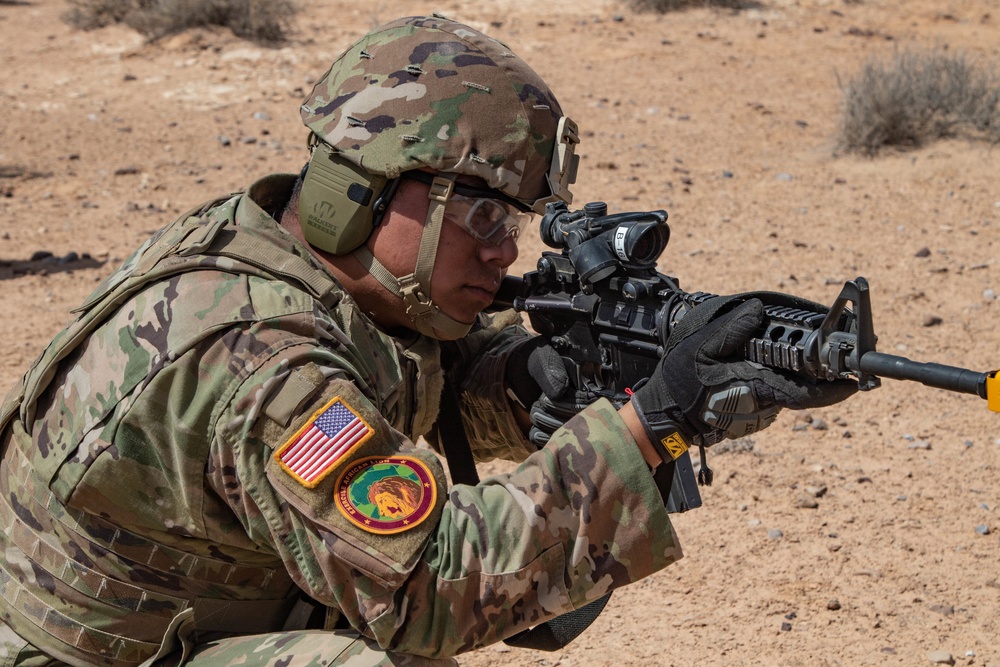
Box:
[839,48,1000,155]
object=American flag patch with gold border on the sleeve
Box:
[274,396,375,488]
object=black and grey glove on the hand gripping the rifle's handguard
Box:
[632,293,857,461]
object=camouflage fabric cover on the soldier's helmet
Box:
[301,16,562,208]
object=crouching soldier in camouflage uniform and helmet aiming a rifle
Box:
[0,16,849,666]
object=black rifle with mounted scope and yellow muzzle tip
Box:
[493,202,1000,512]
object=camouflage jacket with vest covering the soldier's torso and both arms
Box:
[0,176,680,665]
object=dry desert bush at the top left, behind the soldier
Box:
[64,0,295,44]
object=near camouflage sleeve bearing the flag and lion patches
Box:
[209,334,680,657]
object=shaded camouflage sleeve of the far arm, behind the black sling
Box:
[447,310,538,463]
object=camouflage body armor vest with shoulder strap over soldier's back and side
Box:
[0,190,352,665]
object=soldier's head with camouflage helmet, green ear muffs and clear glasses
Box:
[298,16,578,339]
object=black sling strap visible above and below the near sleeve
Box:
[438,381,611,651]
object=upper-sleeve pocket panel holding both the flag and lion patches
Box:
[267,379,446,581]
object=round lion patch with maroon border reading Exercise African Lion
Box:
[335,456,437,535]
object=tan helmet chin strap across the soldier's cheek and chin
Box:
[354,174,472,340]
